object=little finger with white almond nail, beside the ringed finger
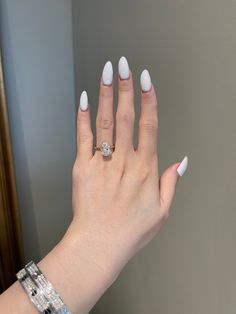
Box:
[77,91,93,160]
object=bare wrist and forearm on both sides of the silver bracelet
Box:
[0,222,122,314]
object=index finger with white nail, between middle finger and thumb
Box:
[138,70,158,161]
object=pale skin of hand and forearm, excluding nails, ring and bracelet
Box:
[0,59,188,314]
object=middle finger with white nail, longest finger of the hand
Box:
[116,57,135,154]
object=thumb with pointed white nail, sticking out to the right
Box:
[160,156,188,211]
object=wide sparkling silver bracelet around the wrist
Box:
[16,261,71,314]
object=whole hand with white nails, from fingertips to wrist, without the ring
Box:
[68,57,188,269]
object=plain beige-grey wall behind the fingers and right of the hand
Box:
[73,0,236,314]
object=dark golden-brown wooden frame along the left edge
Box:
[0,50,25,293]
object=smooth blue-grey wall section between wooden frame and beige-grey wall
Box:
[0,0,75,260]
